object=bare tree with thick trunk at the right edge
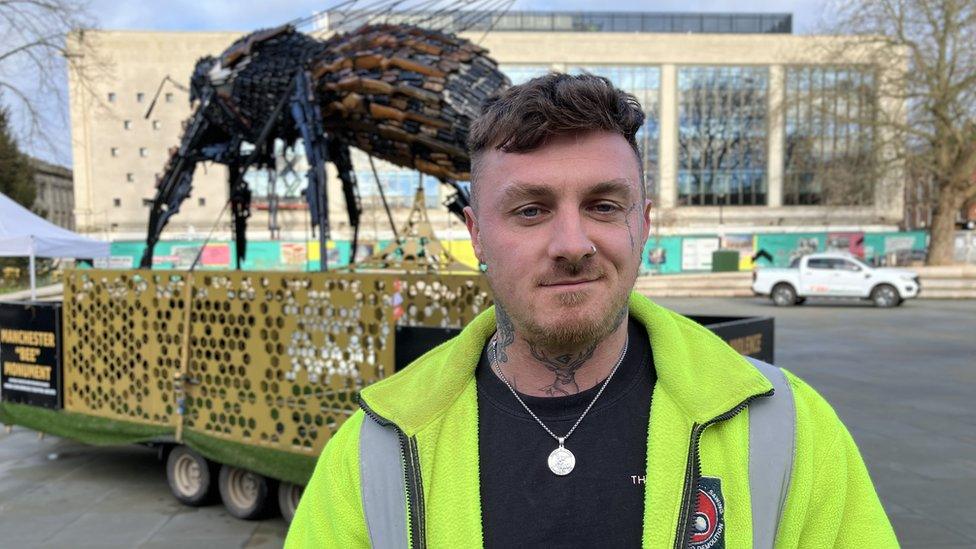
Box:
[831,0,976,265]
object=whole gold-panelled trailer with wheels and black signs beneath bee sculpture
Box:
[0,270,773,520]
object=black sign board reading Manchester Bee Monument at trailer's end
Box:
[0,303,62,409]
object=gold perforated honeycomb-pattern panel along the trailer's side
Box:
[59,271,491,453]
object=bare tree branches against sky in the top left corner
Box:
[0,0,92,161]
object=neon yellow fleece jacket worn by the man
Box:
[285,293,898,549]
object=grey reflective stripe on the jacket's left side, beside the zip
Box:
[359,416,408,549]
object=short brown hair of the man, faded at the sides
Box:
[468,72,645,203]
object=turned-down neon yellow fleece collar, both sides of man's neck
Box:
[361,292,772,436]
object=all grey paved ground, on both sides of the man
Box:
[0,299,976,549]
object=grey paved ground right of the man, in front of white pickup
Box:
[657,298,976,549]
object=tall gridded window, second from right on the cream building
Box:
[678,66,769,205]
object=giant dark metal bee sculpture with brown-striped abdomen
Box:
[140,24,509,270]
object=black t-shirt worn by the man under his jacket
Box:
[476,320,655,548]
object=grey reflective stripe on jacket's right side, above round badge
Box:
[746,357,796,549]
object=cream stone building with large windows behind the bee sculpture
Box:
[70,12,905,244]
